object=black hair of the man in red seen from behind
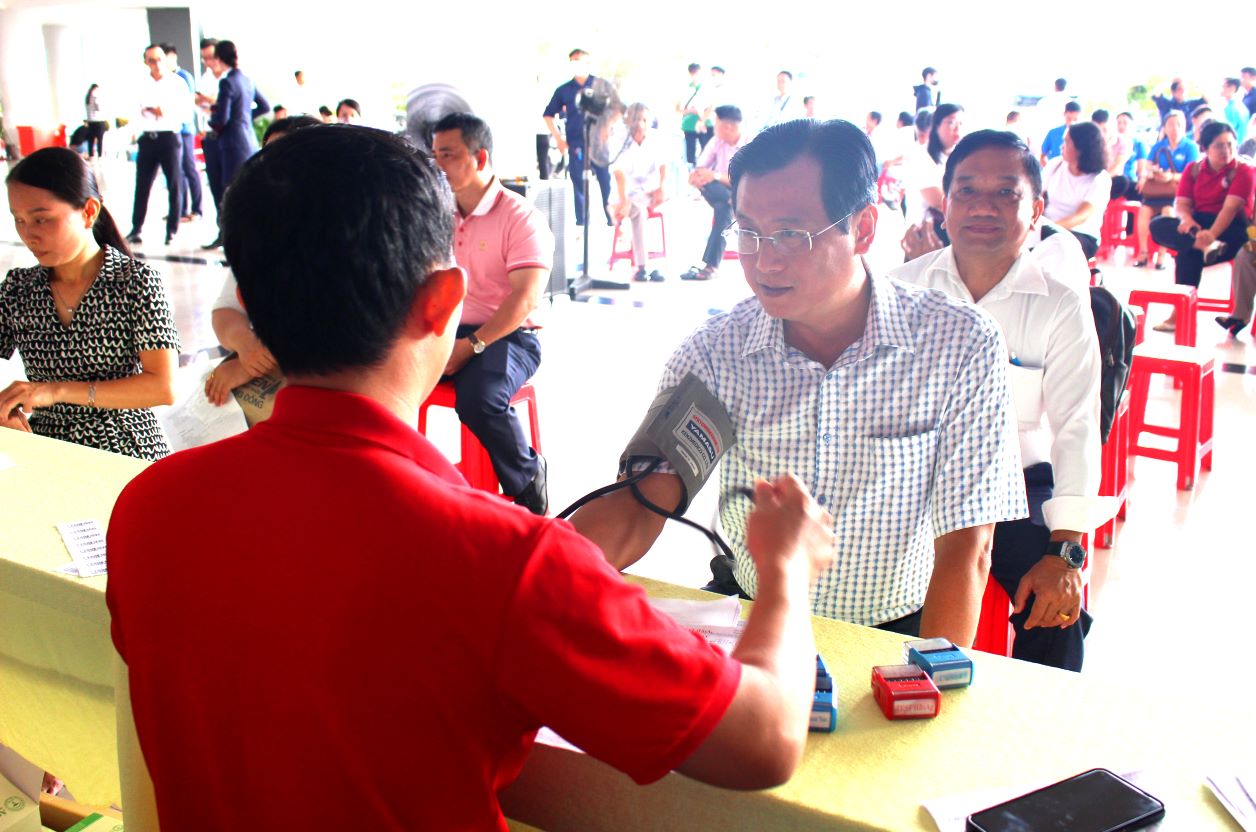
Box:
[222,124,453,375]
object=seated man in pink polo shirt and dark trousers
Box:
[432,113,554,514]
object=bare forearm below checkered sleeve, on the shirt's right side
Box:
[921,524,995,647]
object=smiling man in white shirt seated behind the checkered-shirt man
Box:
[891,131,1113,670]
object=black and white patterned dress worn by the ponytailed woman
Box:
[0,246,180,459]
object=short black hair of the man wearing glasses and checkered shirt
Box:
[728,118,878,234]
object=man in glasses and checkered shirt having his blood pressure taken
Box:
[573,121,1027,645]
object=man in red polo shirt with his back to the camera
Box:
[107,127,831,832]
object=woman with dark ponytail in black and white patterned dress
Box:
[0,147,178,459]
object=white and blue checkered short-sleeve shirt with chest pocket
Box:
[659,276,1027,625]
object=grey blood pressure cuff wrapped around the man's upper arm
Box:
[619,373,736,515]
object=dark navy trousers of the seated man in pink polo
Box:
[453,324,541,496]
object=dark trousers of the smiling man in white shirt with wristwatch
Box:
[990,463,1093,671]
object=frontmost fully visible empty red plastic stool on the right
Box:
[1129,344,1213,490]
